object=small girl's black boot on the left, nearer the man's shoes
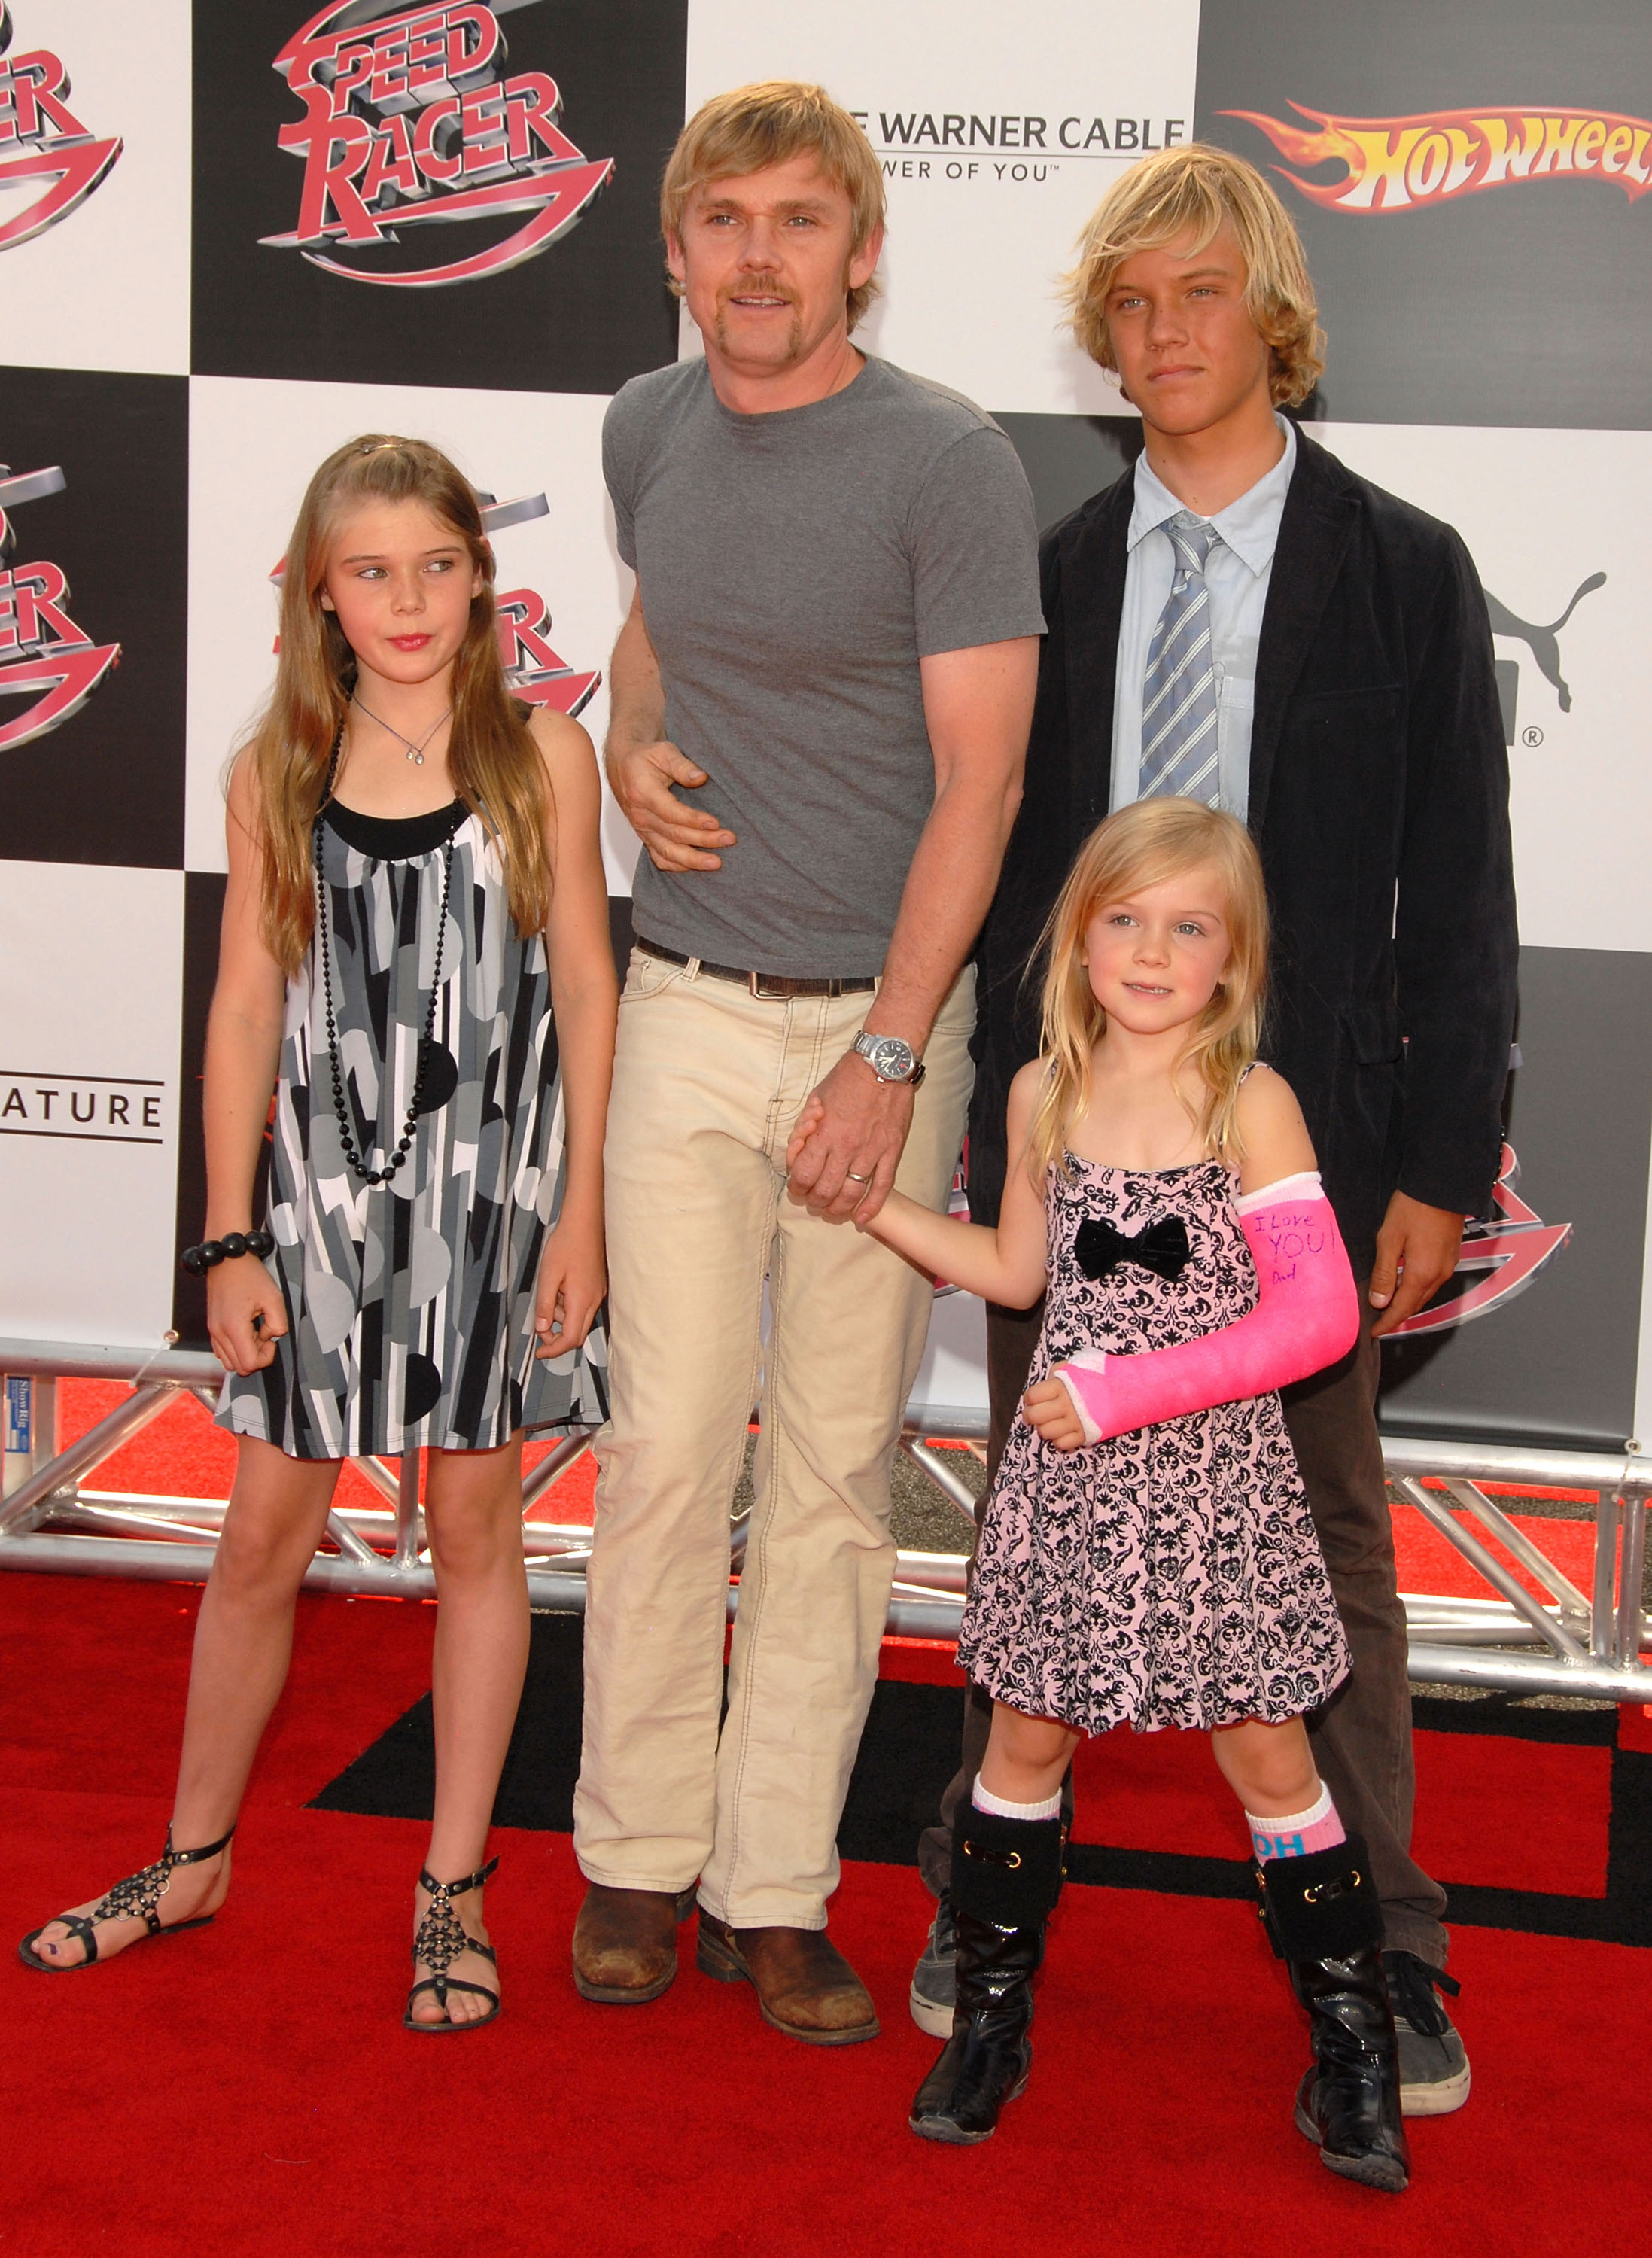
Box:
[909,1806,1065,2143]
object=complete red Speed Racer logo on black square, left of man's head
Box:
[264,0,614,289]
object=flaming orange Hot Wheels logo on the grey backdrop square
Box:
[1221,102,1652,212]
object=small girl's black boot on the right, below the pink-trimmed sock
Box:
[1259,1836,1410,2195]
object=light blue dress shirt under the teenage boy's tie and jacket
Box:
[1112,415,1295,822]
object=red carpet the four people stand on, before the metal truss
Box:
[0,1576,1652,2258]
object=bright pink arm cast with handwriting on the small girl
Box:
[1051,1172,1358,1443]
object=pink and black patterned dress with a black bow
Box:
[957,1154,1347,1734]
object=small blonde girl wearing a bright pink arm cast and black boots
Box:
[799,799,1408,2190]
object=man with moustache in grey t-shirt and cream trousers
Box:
[573,84,1042,2046]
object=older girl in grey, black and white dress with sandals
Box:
[23,436,616,2032]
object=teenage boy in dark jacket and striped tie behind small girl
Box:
[911,145,1517,2116]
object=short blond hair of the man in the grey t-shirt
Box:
[659,79,882,330]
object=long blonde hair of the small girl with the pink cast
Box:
[1027,799,1268,1190]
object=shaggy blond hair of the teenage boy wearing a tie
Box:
[1065,142,1325,406]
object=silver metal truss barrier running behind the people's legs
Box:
[0,1339,1652,1705]
